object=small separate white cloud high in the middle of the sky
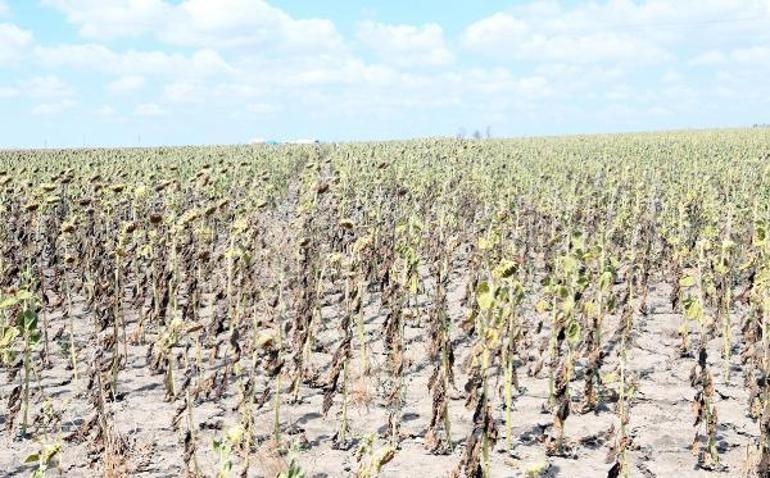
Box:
[356,21,453,66]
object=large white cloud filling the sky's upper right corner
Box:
[462,0,770,65]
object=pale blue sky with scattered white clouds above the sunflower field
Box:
[0,0,770,148]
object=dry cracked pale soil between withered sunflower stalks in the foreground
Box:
[0,258,758,478]
